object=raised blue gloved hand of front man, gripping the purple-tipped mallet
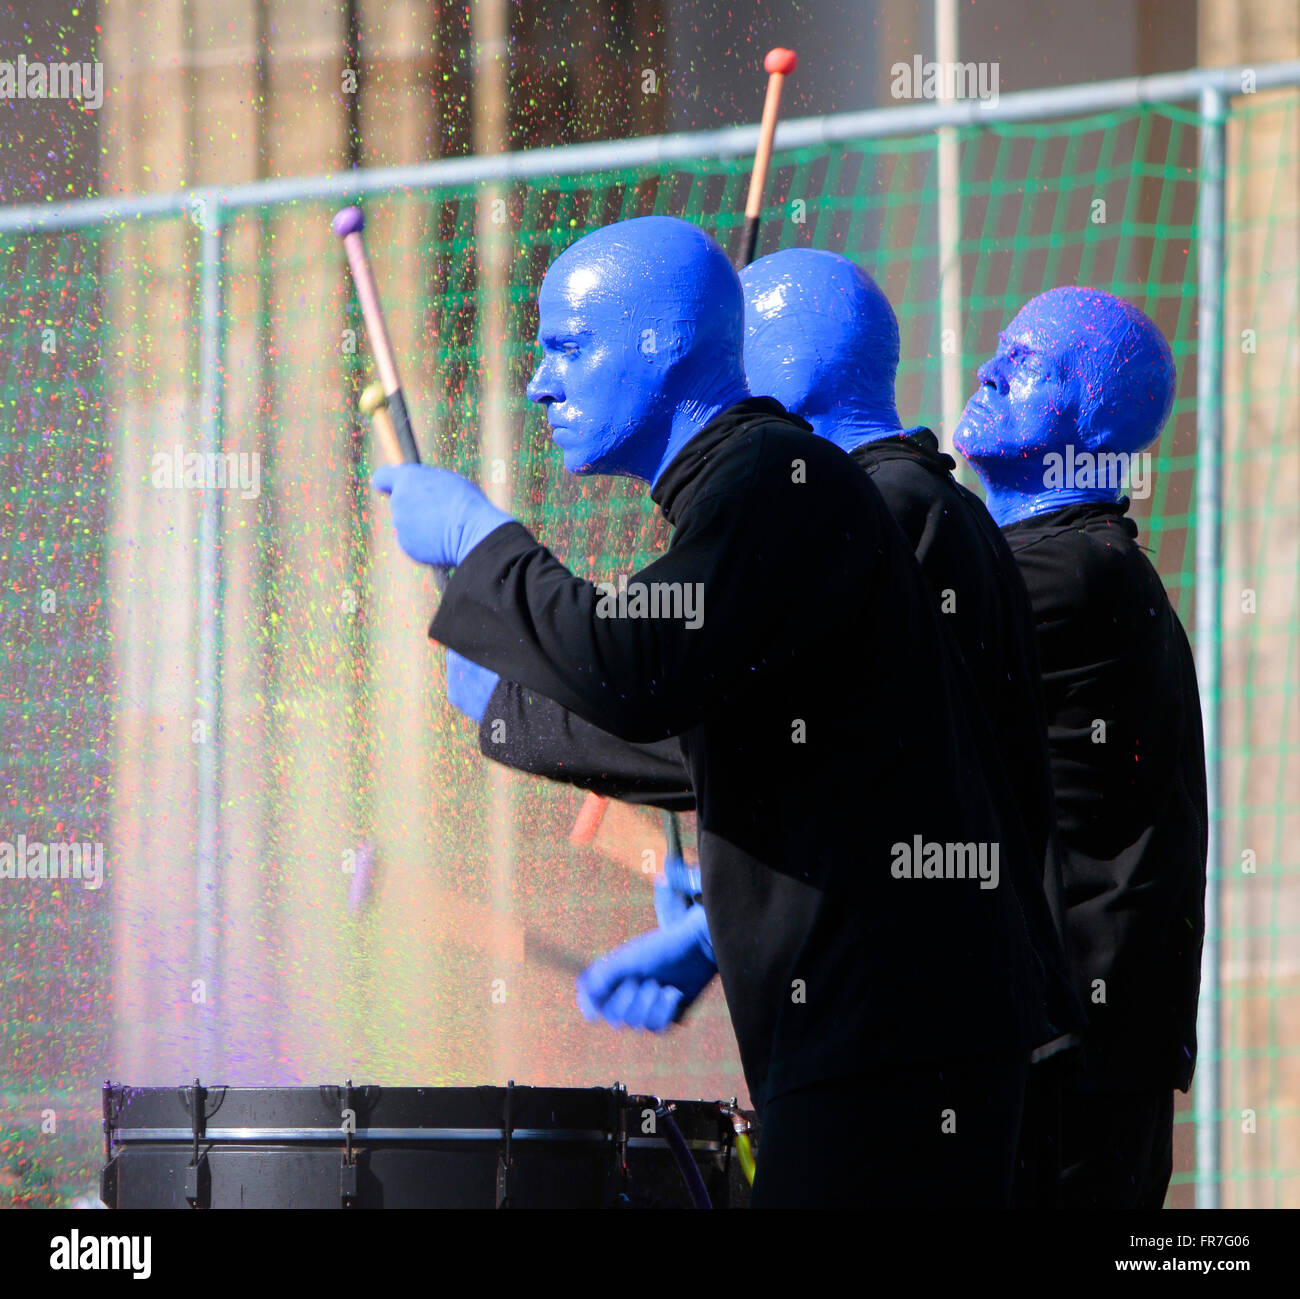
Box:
[371,464,514,568]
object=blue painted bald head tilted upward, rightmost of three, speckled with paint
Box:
[953,287,1177,525]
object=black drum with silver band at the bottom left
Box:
[100,1083,749,1209]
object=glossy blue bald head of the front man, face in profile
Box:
[528,217,749,482]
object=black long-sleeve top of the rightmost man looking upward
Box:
[1004,502,1208,1091]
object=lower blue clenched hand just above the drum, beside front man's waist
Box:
[576,906,718,1032]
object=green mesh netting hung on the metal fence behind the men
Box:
[0,91,1300,1207]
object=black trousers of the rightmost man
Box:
[1061,1086,1174,1209]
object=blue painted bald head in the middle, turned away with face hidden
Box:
[740,248,901,451]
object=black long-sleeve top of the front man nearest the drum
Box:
[430,398,1053,1105]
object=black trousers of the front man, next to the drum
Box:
[751,1055,1028,1209]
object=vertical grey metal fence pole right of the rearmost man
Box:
[1195,86,1227,1209]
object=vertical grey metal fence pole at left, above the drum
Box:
[191,198,225,1078]
